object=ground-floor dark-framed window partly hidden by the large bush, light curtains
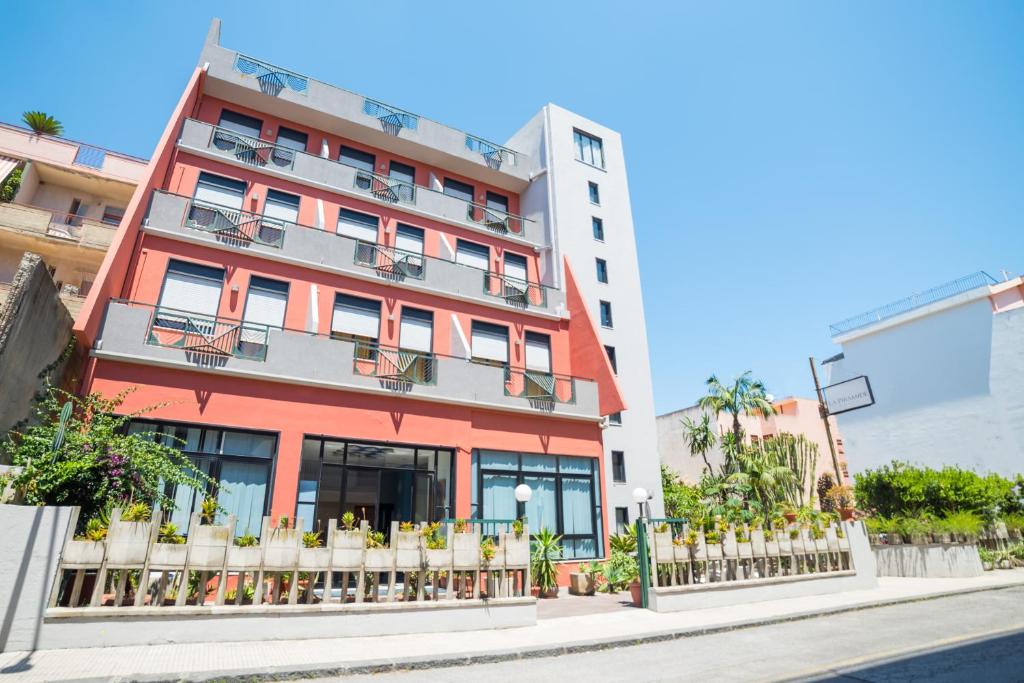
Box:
[128,420,278,536]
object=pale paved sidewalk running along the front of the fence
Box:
[0,569,1024,683]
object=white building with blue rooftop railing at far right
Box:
[822,272,1024,474]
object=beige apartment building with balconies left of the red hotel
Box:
[0,124,146,315]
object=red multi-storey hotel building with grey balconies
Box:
[76,20,659,573]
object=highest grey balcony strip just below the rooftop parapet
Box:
[178,119,545,247]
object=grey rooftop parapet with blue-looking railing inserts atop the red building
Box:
[200,45,534,188]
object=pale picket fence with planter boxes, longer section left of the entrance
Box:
[49,509,529,609]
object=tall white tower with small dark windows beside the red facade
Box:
[509,104,663,533]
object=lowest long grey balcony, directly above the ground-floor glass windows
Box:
[93,300,600,421]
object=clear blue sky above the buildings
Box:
[0,0,1024,413]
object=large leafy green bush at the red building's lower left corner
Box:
[0,387,211,524]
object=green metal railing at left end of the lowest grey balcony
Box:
[146,306,271,361]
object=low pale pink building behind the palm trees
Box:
[657,396,849,483]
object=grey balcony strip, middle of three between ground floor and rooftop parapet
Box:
[143,189,565,317]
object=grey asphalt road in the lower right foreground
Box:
[311,588,1024,683]
